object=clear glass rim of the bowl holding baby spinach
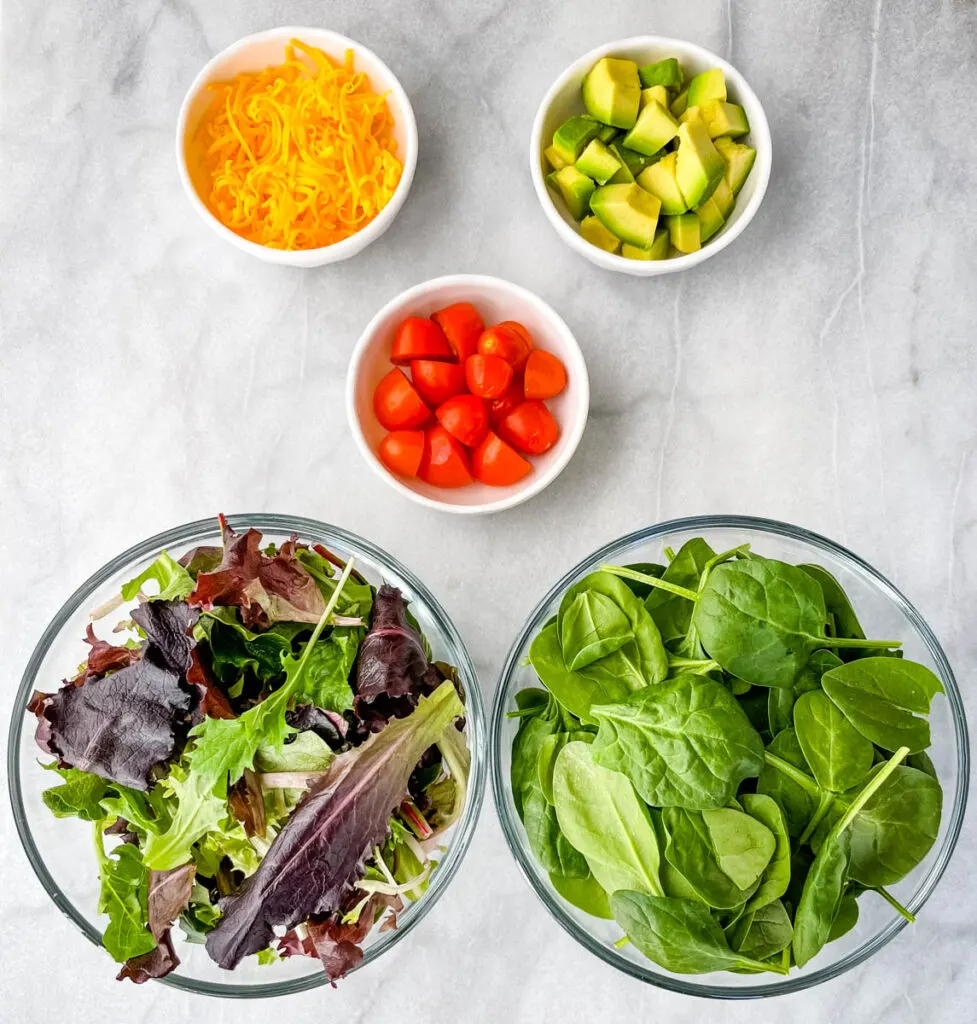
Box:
[490,515,970,999]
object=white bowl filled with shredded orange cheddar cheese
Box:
[176,28,418,266]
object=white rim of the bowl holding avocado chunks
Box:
[529,36,773,278]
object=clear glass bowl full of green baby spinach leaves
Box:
[492,516,969,998]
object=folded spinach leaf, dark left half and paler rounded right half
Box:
[662,807,776,910]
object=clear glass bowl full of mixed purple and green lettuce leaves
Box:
[7,513,486,997]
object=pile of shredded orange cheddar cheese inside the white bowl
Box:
[187,39,402,249]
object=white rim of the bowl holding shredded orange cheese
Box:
[176,26,418,267]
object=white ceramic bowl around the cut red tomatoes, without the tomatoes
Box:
[346,273,590,515]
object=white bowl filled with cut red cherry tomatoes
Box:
[346,274,590,514]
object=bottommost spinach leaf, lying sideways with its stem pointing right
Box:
[610,891,787,974]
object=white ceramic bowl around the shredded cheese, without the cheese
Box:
[176,27,418,266]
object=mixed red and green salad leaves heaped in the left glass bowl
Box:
[29,517,469,982]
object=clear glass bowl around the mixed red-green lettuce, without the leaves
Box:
[7,514,486,997]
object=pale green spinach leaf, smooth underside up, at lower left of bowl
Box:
[553,742,662,896]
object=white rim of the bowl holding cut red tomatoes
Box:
[346,273,590,515]
